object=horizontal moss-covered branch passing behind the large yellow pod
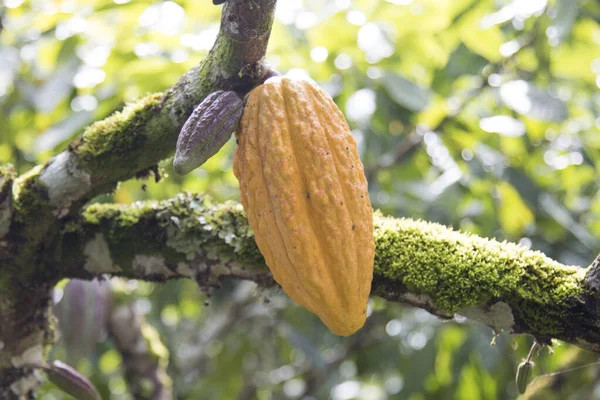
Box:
[54,195,600,352]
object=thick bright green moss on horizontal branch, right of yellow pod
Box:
[375,214,584,333]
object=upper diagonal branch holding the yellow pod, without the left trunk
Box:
[12,0,276,260]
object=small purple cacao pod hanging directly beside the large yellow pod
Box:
[173,90,244,175]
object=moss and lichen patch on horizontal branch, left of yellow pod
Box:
[83,194,264,273]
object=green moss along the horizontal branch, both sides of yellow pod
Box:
[77,198,585,335]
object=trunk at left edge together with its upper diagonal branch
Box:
[0,0,276,399]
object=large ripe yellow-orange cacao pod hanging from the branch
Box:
[233,77,375,336]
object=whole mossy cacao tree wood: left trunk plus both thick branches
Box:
[0,0,600,400]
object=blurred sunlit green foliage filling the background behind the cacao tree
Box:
[0,0,600,400]
